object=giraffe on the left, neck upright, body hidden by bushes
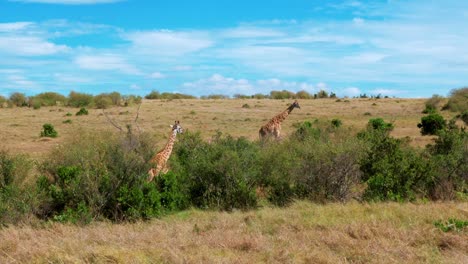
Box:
[148,121,184,182]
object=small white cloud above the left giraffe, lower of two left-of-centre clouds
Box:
[75,54,141,75]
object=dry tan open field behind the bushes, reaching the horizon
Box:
[0,98,454,157]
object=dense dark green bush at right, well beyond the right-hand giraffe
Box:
[360,129,433,201]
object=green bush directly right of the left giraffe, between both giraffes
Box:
[175,132,259,210]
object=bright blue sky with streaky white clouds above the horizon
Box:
[0,0,468,97]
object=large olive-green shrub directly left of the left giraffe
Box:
[37,131,165,223]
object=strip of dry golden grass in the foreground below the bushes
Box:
[0,202,468,263]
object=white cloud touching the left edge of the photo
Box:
[0,36,69,56]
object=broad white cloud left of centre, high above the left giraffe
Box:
[123,30,214,56]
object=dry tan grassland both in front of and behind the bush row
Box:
[0,98,468,263]
